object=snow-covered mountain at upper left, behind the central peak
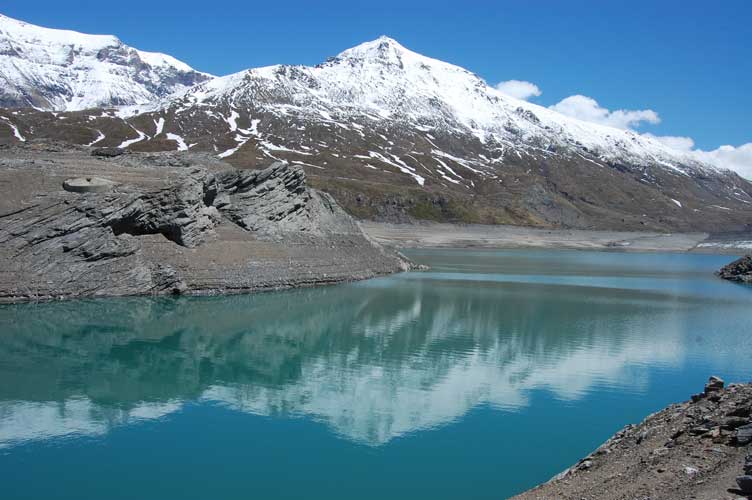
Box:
[0,14,211,111]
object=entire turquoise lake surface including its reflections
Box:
[0,250,752,500]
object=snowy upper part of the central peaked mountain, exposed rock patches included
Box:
[166,37,705,174]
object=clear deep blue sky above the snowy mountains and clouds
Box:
[5,0,752,150]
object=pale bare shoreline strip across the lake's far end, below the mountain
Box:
[360,221,752,255]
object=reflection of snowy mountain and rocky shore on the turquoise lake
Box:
[0,249,749,447]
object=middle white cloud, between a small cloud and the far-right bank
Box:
[550,95,661,129]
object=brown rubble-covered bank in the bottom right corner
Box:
[514,377,752,500]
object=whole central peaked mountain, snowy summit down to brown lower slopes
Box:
[0,21,752,231]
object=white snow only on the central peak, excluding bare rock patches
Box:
[157,36,714,176]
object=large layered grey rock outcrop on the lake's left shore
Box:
[0,144,410,302]
